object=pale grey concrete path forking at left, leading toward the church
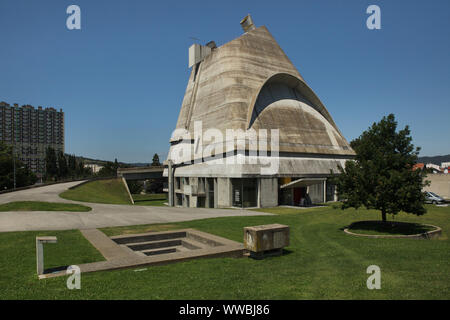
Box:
[0,181,270,232]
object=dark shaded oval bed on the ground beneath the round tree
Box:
[341,221,434,235]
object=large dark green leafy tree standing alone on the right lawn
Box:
[333,114,428,222]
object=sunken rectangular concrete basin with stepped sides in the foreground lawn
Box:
[40,229,244,278]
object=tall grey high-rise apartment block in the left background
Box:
[0,102,64,177]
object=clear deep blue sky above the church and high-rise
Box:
[0,0,450,162]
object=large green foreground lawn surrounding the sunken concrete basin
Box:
[0,206,450,299]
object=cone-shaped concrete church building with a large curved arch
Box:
[164,16,354,208]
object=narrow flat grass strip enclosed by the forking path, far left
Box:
[0,201,92,212]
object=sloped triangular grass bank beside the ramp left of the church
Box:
[59,179,131,204]
